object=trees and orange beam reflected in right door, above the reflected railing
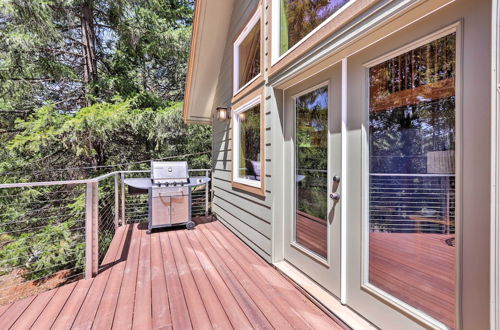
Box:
[370,34,455,173]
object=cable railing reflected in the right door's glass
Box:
[369,174,455,234]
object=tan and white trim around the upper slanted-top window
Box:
[233,4,264,97]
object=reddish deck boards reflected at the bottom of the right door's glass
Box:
[370,233,455,328]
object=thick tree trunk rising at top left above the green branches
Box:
[81,0,97,106]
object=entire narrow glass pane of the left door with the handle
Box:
[295,86,328,258]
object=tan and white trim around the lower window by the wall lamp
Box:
[231,90,266,196]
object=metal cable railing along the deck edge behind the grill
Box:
[0,169,212,305]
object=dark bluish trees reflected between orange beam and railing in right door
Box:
[370,96,456,174]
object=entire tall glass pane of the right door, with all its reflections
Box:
[369,34,456,328]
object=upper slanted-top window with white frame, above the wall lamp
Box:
[233,6,262,95]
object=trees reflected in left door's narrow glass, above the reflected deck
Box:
[296,87,328,219]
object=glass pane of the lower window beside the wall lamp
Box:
[238,105,261,181]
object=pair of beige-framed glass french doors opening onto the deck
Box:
[283,0,491,329]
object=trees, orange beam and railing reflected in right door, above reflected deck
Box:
[369,34,456,234]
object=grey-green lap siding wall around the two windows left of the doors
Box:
[212,0,272,262]
